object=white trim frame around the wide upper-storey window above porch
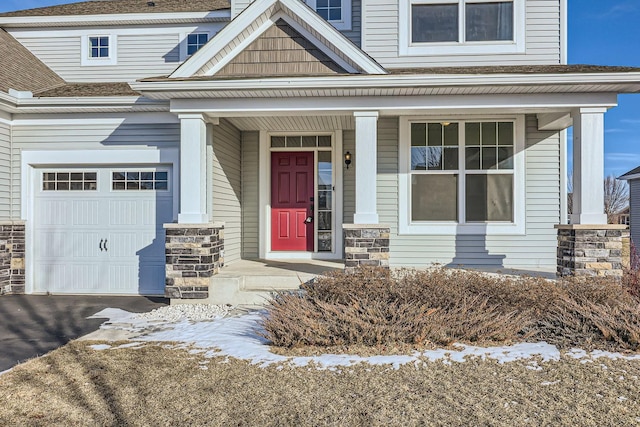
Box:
[398,0,526,56]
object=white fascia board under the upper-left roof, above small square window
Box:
[0,9,231,28]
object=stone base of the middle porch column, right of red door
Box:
[342,224,391,273]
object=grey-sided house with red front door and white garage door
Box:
[0,0,640,299]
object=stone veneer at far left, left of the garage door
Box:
[0,221,25,295]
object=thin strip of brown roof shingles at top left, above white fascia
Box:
[0,0,231,17]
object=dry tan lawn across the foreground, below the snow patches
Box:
[0,342,640,426]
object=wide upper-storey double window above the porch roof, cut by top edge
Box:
[400,0,525,55]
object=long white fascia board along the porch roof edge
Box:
[131,72,640,92]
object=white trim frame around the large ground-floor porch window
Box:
[398,115,526,235]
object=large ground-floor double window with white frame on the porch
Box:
[400,119,524,234]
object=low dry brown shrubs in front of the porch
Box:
[263,269,640,350]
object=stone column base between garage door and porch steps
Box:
[164,223,224,299]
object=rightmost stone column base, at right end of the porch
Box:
[555,224,627,277]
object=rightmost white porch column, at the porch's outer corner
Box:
[571,108,607,225]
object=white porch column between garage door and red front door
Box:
[178,114,209,224]
